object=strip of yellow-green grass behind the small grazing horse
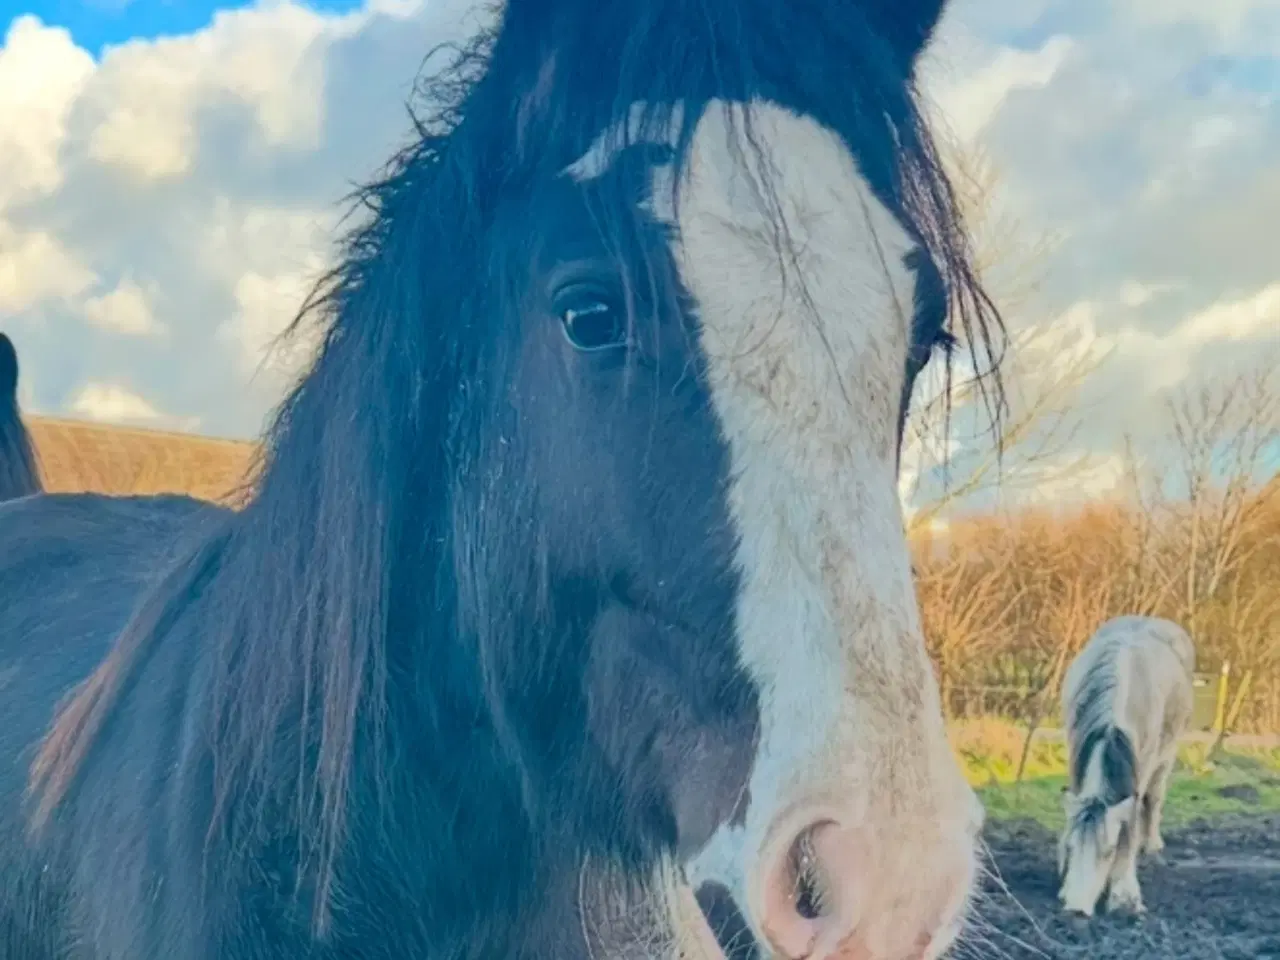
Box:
[951,719,1280,831]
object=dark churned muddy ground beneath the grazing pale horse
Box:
[955,814,1280,960]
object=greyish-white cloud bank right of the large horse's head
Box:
[925,0,1280,512]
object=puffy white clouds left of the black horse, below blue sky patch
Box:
[0,0,479,435]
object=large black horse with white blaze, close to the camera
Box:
[0,0,1004,960]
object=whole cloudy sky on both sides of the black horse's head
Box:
[0,0,1280,512]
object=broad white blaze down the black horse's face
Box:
[567,100,980,955]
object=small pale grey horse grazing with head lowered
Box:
[1059,616,1196,916]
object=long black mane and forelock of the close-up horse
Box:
[22,0,1000,942]
